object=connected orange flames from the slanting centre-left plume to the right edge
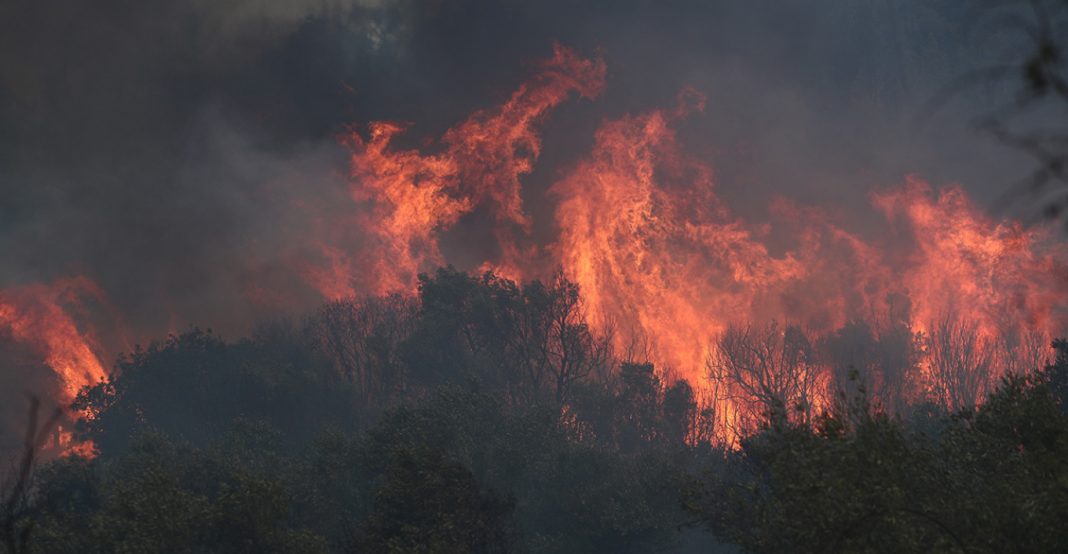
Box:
[320,46,1068,435]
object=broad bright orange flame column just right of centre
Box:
[552,91,805,377]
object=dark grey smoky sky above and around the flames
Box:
[0,0,1042,352]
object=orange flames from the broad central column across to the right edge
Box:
[552,100,1068,424]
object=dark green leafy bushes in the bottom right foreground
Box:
[691,343,1068,552]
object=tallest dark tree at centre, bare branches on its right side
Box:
[406,268,610,405]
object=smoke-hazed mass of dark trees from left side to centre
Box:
[18,269,717,553]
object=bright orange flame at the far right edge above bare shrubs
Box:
[873,178,1068,338]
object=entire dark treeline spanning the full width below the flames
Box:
[0,269,1068,553]
